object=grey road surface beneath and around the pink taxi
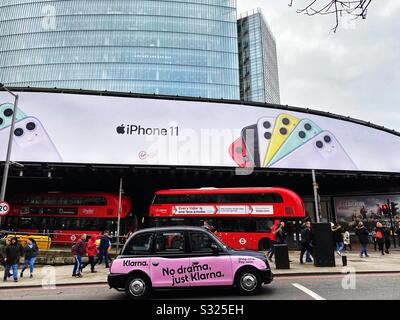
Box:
[0,274,400,301]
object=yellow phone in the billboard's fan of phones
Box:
[263,113,300,167]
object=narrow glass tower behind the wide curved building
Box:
[238,9,280,104]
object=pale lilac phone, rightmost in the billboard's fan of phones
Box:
[271,131,358,170]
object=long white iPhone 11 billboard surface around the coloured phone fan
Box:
[0,92,400,172]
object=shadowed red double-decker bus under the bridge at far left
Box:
[2,192,134,244]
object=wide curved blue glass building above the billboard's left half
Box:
[0,0,240,99]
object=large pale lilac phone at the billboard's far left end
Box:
[0,117,62,162]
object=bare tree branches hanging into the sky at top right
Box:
[288,0,372,32]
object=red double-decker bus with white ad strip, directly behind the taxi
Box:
[149,188,305,250]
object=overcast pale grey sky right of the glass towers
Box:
[237,0,400,131]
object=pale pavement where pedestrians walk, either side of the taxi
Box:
[0,250,400,290]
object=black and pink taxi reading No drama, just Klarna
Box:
[108,226,273,299]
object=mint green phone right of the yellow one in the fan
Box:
[269,118,322,166]
